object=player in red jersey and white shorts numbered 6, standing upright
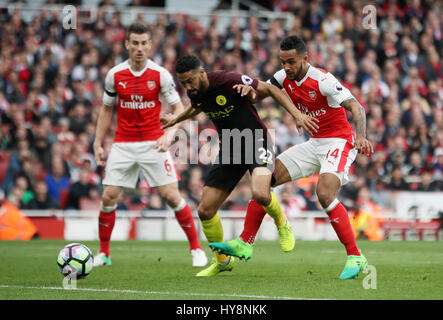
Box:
[94,22,207,267]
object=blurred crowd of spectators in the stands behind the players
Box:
[0,0,443,219]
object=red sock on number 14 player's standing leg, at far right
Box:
[326,199,360,256]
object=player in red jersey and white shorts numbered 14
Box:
[210,36,373,279]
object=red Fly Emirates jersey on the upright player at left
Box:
[103,60,180,142]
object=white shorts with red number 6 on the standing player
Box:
[103,141,179,188]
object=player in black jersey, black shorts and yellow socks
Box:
[163,55,318,276]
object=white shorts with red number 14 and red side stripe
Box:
[277,138,358,185]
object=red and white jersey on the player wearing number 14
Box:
[269,65,353,140]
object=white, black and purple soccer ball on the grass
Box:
[57,243,94,279]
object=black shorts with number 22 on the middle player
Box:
[205,132,275,191]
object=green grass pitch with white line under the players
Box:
[0,240,443,300]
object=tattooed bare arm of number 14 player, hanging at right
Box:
[340,98,374,156]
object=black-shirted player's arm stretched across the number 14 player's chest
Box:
[256,81,319,136]
